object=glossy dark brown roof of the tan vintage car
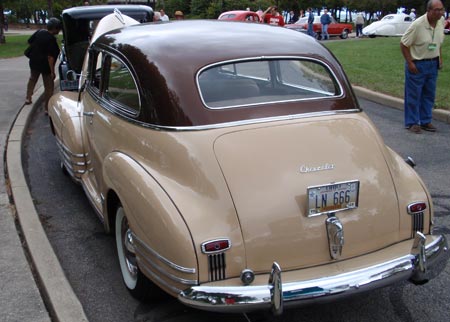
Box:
[96,20,357,126]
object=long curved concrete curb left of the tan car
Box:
[6,87,88,322]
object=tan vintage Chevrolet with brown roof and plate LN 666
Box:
[49,11,448,314]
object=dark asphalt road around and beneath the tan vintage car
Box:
[24,101,450,322]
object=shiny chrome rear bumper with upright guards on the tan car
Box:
[178,232,449,315]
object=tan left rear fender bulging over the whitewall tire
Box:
[103,152,198,296]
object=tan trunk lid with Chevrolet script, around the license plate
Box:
[214,113,399,271]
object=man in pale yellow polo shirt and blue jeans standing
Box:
[400,0,445,134]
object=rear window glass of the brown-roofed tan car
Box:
[197,59,342,109]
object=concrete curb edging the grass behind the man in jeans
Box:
[353,86,450,124]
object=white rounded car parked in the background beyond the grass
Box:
[363,13,413,37]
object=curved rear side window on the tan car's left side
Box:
[103,56,141,115]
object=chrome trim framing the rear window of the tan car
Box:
[195,56,344,110]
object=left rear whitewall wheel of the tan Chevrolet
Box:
[115,205,156,300]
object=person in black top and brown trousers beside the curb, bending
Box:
[25,18,61,113]
